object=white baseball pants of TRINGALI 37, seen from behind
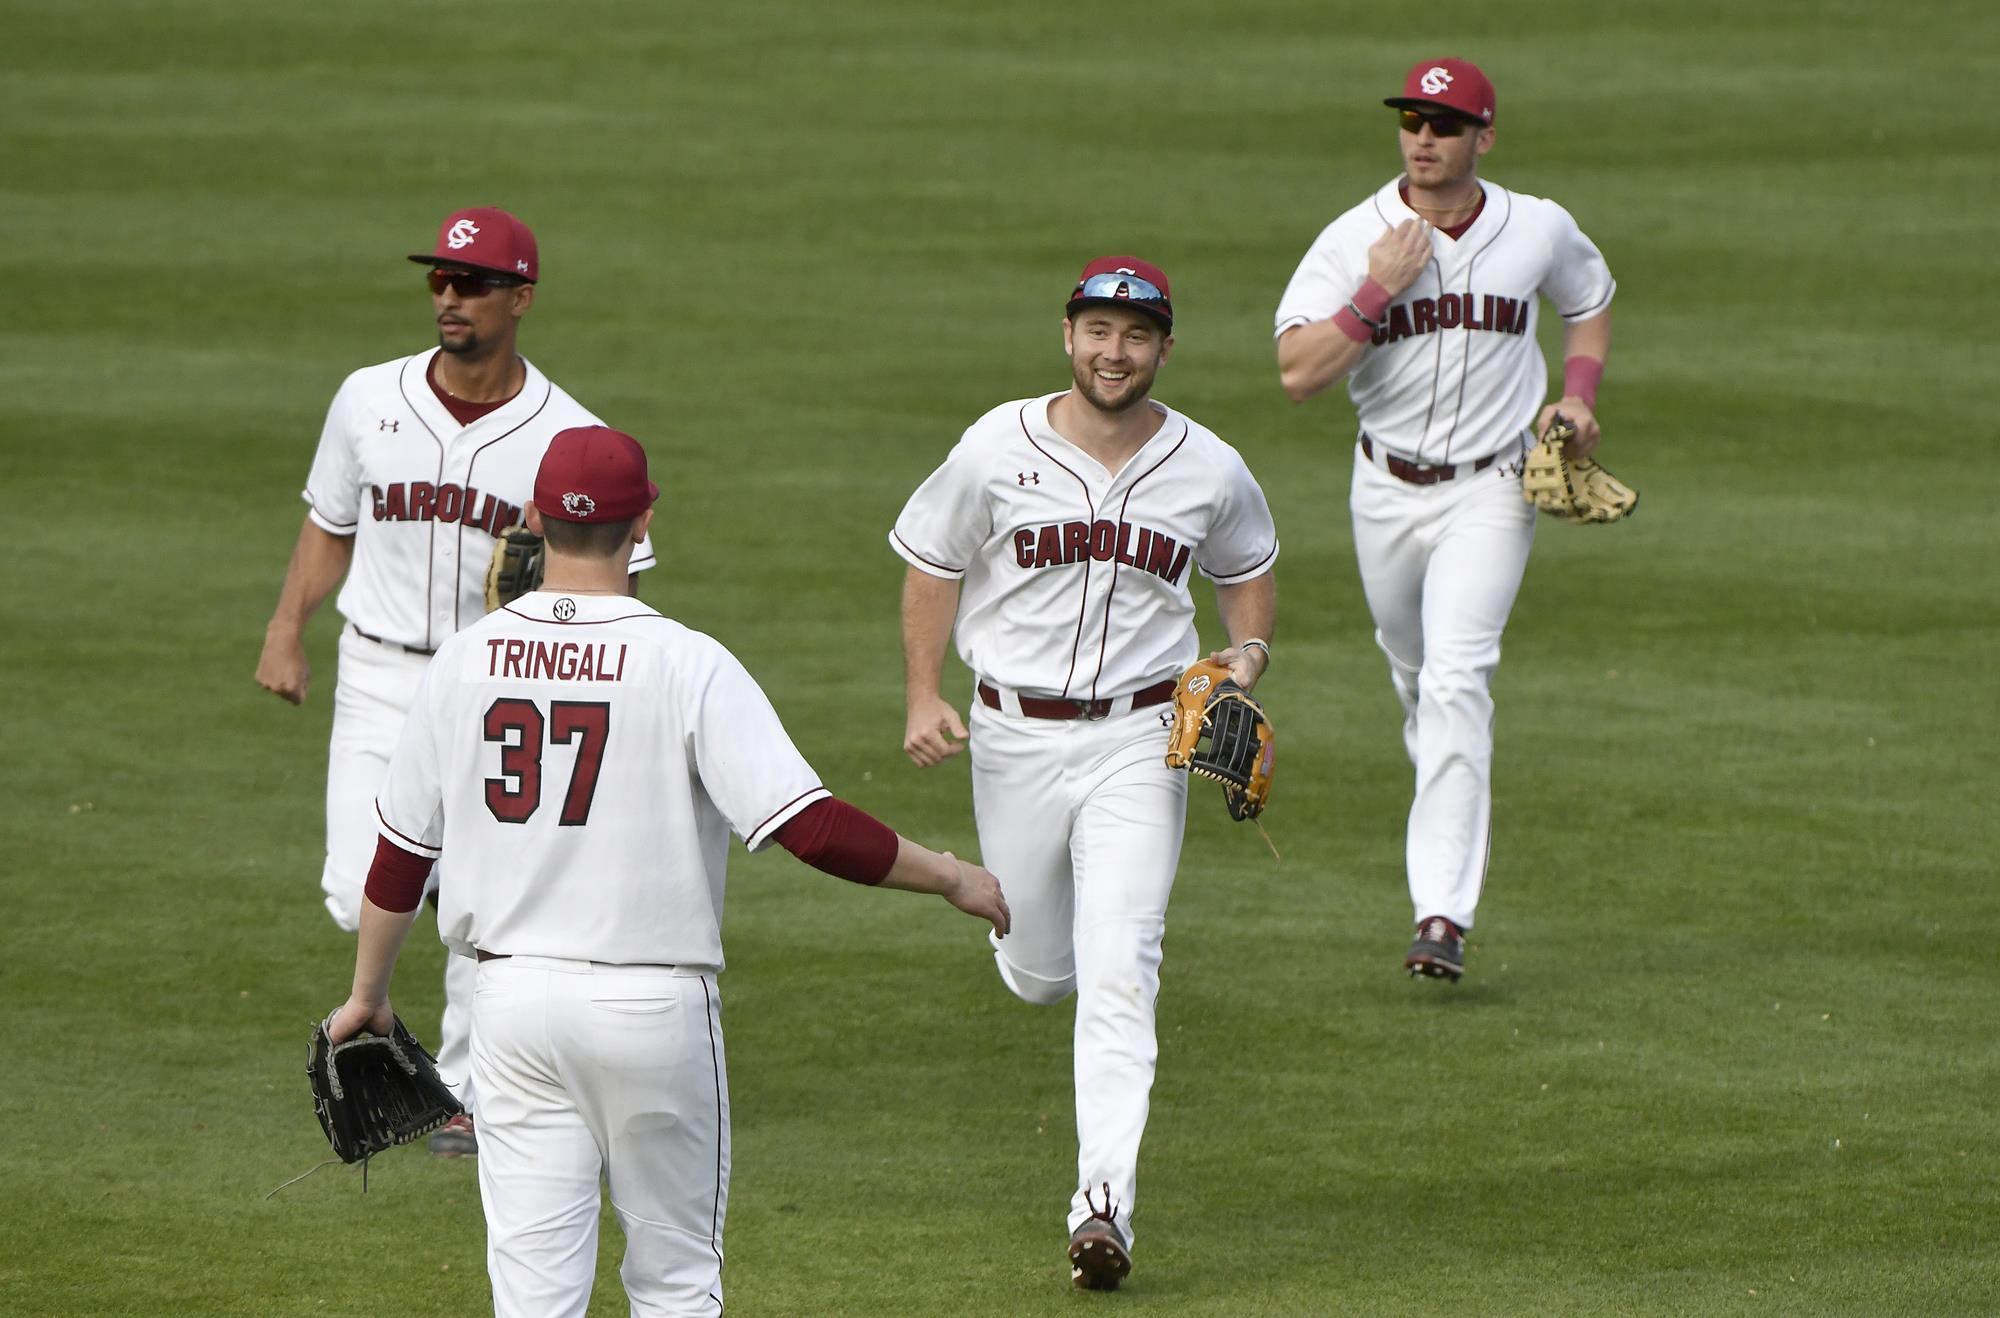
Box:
[472,956,730,1318]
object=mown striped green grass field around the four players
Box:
[0,0,2000,1318]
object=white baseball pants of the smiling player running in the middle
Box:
[970,702,1188,1242]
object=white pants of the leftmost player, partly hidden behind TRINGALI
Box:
[332,626,474,1110]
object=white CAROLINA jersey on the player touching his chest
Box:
[1278,178,1618,464]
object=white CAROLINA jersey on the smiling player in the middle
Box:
[890,394,1278,700]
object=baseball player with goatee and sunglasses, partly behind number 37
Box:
[256,206,654,1156]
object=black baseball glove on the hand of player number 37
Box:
[306,1016,466,1162]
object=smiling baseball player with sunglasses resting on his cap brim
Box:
[890,256,1278,1290]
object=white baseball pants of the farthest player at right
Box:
[1348,446,1534,928]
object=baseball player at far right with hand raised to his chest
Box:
[1278,60,1616,980]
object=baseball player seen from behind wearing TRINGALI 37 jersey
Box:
[328,426,1008,1318]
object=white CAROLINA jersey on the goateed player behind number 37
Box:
[302,348,654,650]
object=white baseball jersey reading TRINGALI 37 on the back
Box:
[376,590,828,970]
